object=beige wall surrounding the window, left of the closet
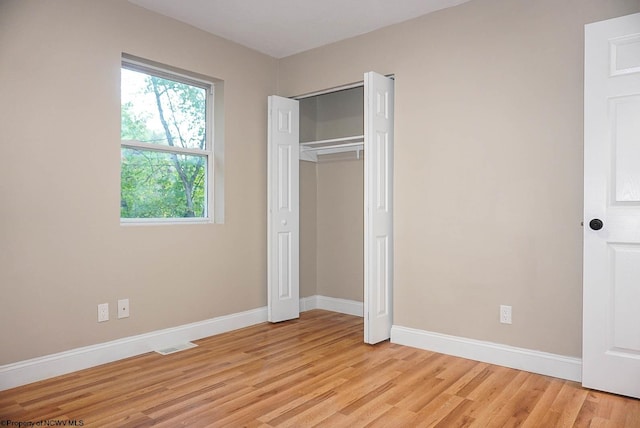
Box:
[0,0,277,365]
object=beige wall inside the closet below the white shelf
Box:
[300,153,364,302]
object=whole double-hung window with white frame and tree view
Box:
[120,58,214,223]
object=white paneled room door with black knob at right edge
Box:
[582,14,640,398]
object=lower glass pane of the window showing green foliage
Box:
[120,147,207,218]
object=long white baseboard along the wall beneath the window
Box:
[0,307,267,391]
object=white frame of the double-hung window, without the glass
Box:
[120,54,218,225]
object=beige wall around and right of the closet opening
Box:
[278,0,640,356]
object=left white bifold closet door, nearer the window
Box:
[267,96,300,322]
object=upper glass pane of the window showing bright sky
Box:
[120,67,207,150]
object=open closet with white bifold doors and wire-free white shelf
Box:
[267,72,394,343]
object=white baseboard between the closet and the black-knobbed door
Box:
[391,325,582,382]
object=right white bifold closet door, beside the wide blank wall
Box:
[364,72,394,344]
